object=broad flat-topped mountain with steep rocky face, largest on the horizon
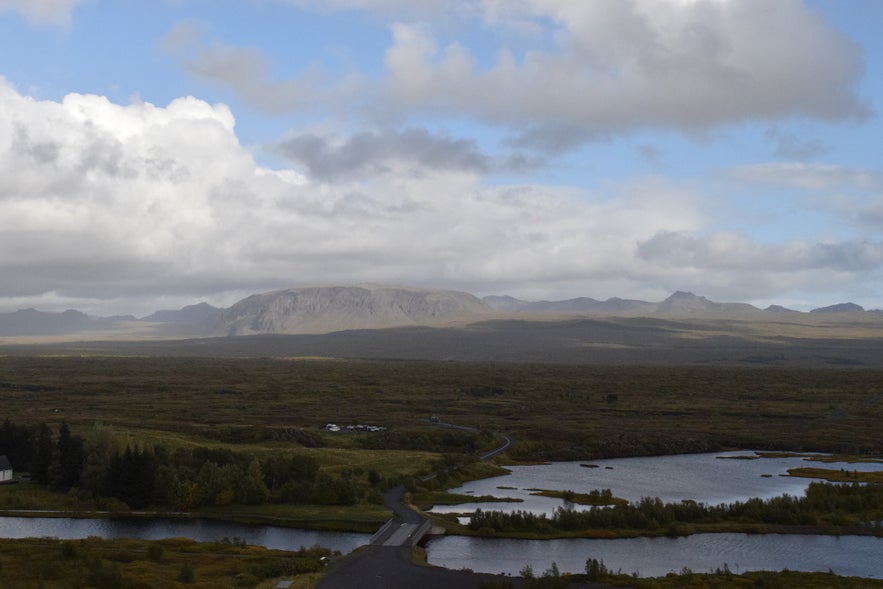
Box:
[215,285,493,335]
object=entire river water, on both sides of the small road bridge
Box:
[0,452,883,578]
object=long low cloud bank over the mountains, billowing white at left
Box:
[0,82,883,315]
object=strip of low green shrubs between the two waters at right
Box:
[468,482,883,534]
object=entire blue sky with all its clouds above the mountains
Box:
[0,0,883,316]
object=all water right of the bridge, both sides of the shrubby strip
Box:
[427,452,883,578]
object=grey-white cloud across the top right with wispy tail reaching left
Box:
[161,0,868,149]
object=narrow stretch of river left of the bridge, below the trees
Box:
[0,517,371,554]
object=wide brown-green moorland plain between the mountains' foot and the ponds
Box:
[0,356,883,460]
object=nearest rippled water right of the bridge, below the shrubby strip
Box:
[427,534,883,578]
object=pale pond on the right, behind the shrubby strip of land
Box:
[431,451,883,515]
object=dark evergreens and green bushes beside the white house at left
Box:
[0,419,386,509]
